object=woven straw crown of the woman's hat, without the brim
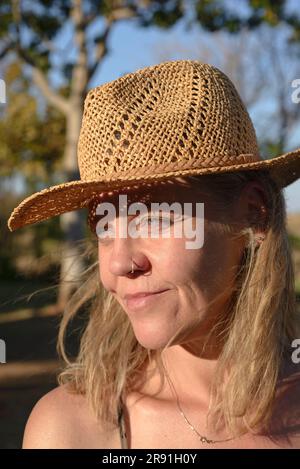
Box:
[78,60,259,181]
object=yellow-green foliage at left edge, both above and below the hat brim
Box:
[0,60,65,279]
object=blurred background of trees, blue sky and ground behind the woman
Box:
[0,0,300,448]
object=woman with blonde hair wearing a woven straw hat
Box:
[9,60,300,448]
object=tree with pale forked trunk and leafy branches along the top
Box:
[0,0,300,305]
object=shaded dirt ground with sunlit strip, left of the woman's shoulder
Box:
[0,281,82,449]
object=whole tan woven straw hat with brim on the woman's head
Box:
[8,60,300,231]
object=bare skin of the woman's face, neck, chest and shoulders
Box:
[23,177,300,449]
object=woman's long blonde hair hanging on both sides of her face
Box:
[58,170,299,435]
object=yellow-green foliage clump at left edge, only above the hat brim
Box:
[0,62,65,190]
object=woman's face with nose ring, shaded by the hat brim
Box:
[98,180,242,349]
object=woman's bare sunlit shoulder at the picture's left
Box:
[22,386,117,449]
